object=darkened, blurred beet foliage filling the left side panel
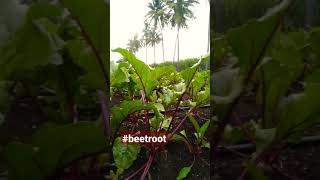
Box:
[0,0,110,180]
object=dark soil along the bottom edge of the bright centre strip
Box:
[121,143,210,180]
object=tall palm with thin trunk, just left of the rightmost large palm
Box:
[146,0,169,62]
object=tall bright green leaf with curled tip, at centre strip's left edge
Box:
[113,48,157,97]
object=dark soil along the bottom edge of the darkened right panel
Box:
[211,142,320,180]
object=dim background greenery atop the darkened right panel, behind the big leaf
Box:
[212,0,320,33]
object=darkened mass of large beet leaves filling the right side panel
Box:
[210,0,320,179]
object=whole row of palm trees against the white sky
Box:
[127,0,199,69]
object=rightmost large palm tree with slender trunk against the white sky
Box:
[166,0,199,69]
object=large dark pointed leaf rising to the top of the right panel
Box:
[227,0,290,76]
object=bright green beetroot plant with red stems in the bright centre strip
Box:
[111,48,210,179]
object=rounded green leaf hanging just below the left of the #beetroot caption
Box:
[112,137,141,170]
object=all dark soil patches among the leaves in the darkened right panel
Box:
[210,89,320,180]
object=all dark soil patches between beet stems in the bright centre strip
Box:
[116,108,210,180]
